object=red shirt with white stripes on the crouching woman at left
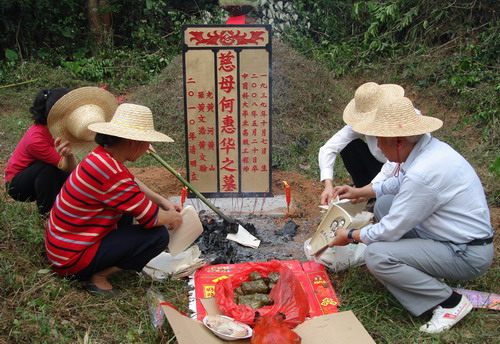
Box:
[45,146,159,275]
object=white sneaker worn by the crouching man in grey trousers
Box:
[420,295,472,333]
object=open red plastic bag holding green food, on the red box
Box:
[215,260,309,328]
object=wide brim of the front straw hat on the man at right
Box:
[352,116,443,137]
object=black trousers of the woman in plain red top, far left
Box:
[5,161,69,214]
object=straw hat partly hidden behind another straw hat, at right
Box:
[343,82,405,126]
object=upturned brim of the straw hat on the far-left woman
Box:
[47,87,118,153]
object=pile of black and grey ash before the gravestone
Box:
[195,215,306,265]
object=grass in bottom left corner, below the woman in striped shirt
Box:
[0,195,188,343]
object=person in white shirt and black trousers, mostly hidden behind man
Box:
[318,82,404,205]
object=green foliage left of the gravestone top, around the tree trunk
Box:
[0,0,220,88]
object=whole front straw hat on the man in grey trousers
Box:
[352,97,443,137]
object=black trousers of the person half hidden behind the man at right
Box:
[340,139,384,188]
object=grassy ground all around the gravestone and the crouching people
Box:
[0,41,500,343]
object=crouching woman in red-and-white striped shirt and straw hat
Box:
[45,104,182,294]
